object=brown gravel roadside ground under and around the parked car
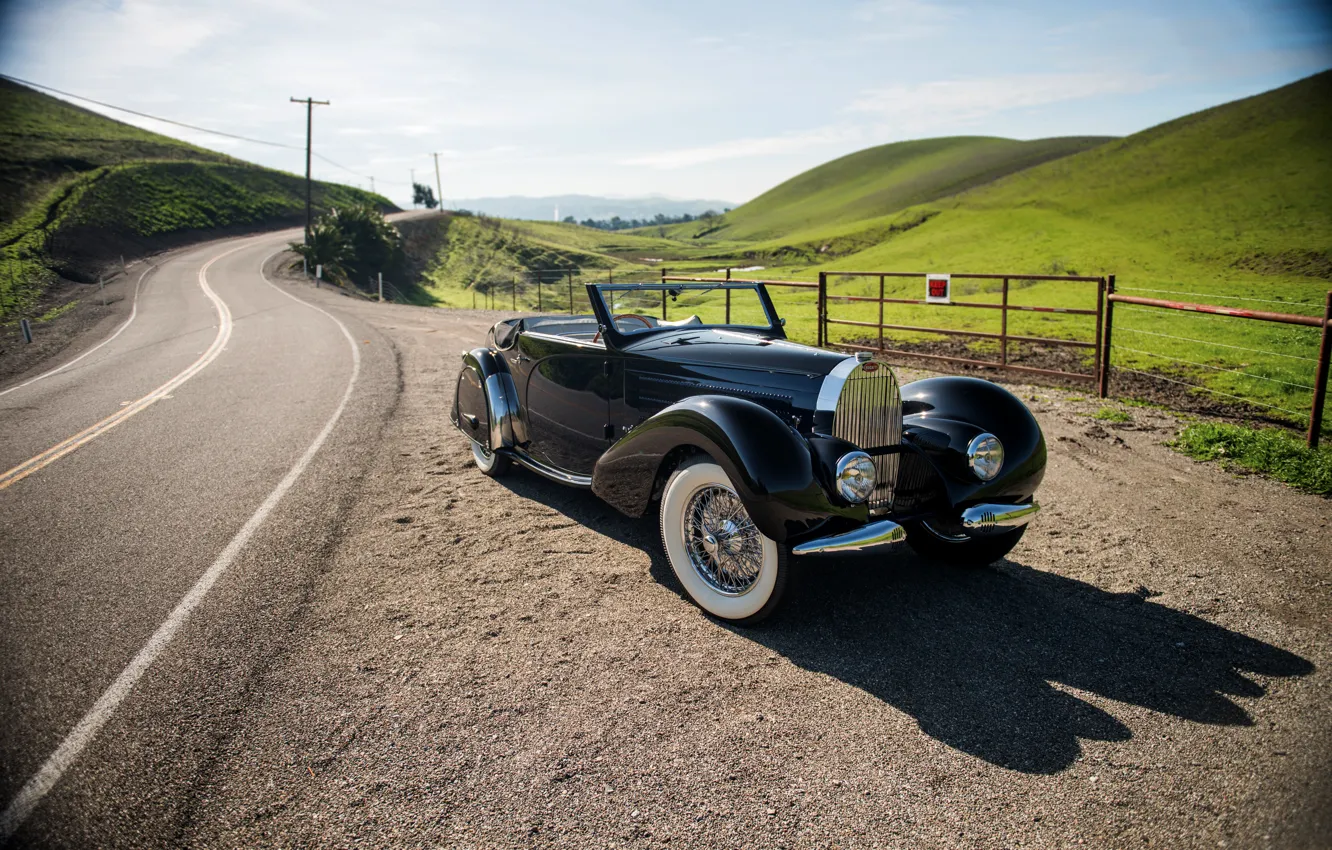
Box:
[158,282,1332,847]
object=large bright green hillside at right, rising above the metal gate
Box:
[829,72,1332,289]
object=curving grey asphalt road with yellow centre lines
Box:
[0,232,396,843]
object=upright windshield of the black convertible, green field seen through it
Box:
[597,284,777,333]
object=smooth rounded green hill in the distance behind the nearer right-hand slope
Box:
[673,136,1110,241]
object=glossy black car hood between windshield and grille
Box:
[623,328,847,380]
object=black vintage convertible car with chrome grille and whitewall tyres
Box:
[453,282,1046,624]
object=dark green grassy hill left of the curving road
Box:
[0,80,393,320]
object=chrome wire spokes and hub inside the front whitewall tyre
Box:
[685,484,763,596]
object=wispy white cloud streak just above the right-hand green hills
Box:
[847,72,1166,125]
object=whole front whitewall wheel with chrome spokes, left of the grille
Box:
[661,458,787,625]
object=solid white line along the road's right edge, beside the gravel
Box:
[0,249,361,842]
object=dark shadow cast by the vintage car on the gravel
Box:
[490,474,1313,774]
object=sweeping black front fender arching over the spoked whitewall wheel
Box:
[591,396,868,542]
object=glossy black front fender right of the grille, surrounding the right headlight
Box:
[902,377,1046,505]
